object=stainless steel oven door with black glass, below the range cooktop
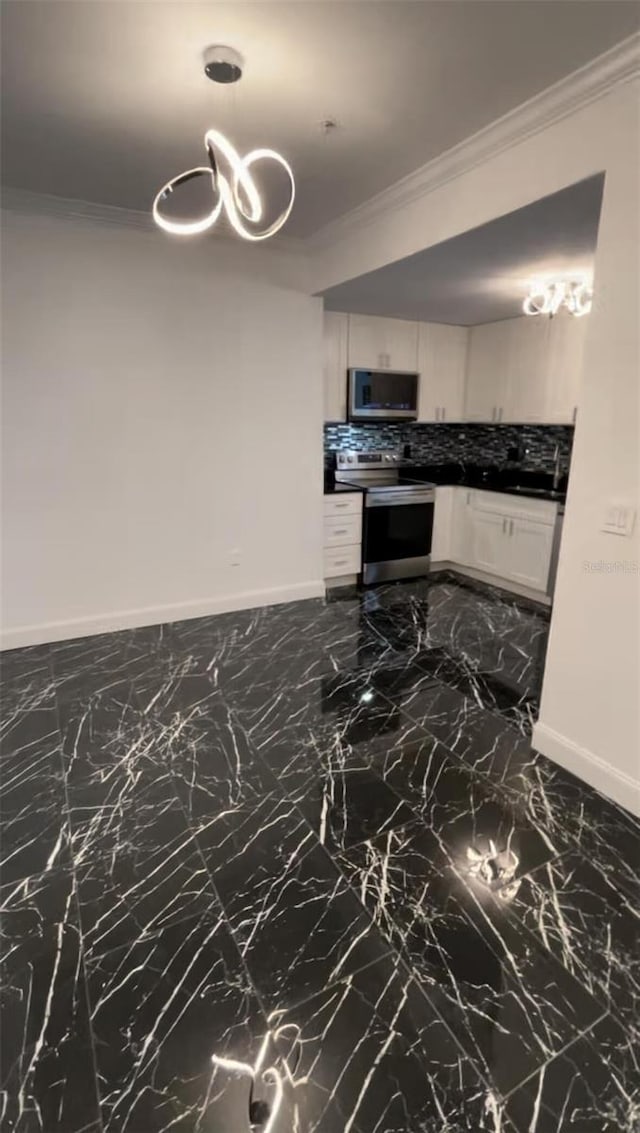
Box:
[362,491,435,583]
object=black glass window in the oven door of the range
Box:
[362,503,434,563]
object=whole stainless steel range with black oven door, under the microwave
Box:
[335,450,435,585]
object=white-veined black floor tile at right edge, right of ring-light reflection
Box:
[496,853,640,1028]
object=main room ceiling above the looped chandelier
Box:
[1,0,640,236]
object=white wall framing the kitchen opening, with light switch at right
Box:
[314,73,640,813]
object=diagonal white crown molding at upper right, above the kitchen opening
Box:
[307,33,640,252]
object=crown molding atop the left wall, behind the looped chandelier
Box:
[0,186,306,255]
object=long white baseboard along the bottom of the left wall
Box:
[0,579,325,649]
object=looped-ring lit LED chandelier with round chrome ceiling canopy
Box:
[153,46,296,240]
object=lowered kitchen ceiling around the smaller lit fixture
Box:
[324,174,604,326]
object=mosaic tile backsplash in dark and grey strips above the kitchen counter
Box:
[324,424,573,471]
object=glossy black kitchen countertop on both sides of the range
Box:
[324,463,568,504]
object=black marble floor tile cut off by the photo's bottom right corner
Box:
[506,1016,640,1133]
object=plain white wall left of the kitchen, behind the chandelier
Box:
[2,212,323,647]
